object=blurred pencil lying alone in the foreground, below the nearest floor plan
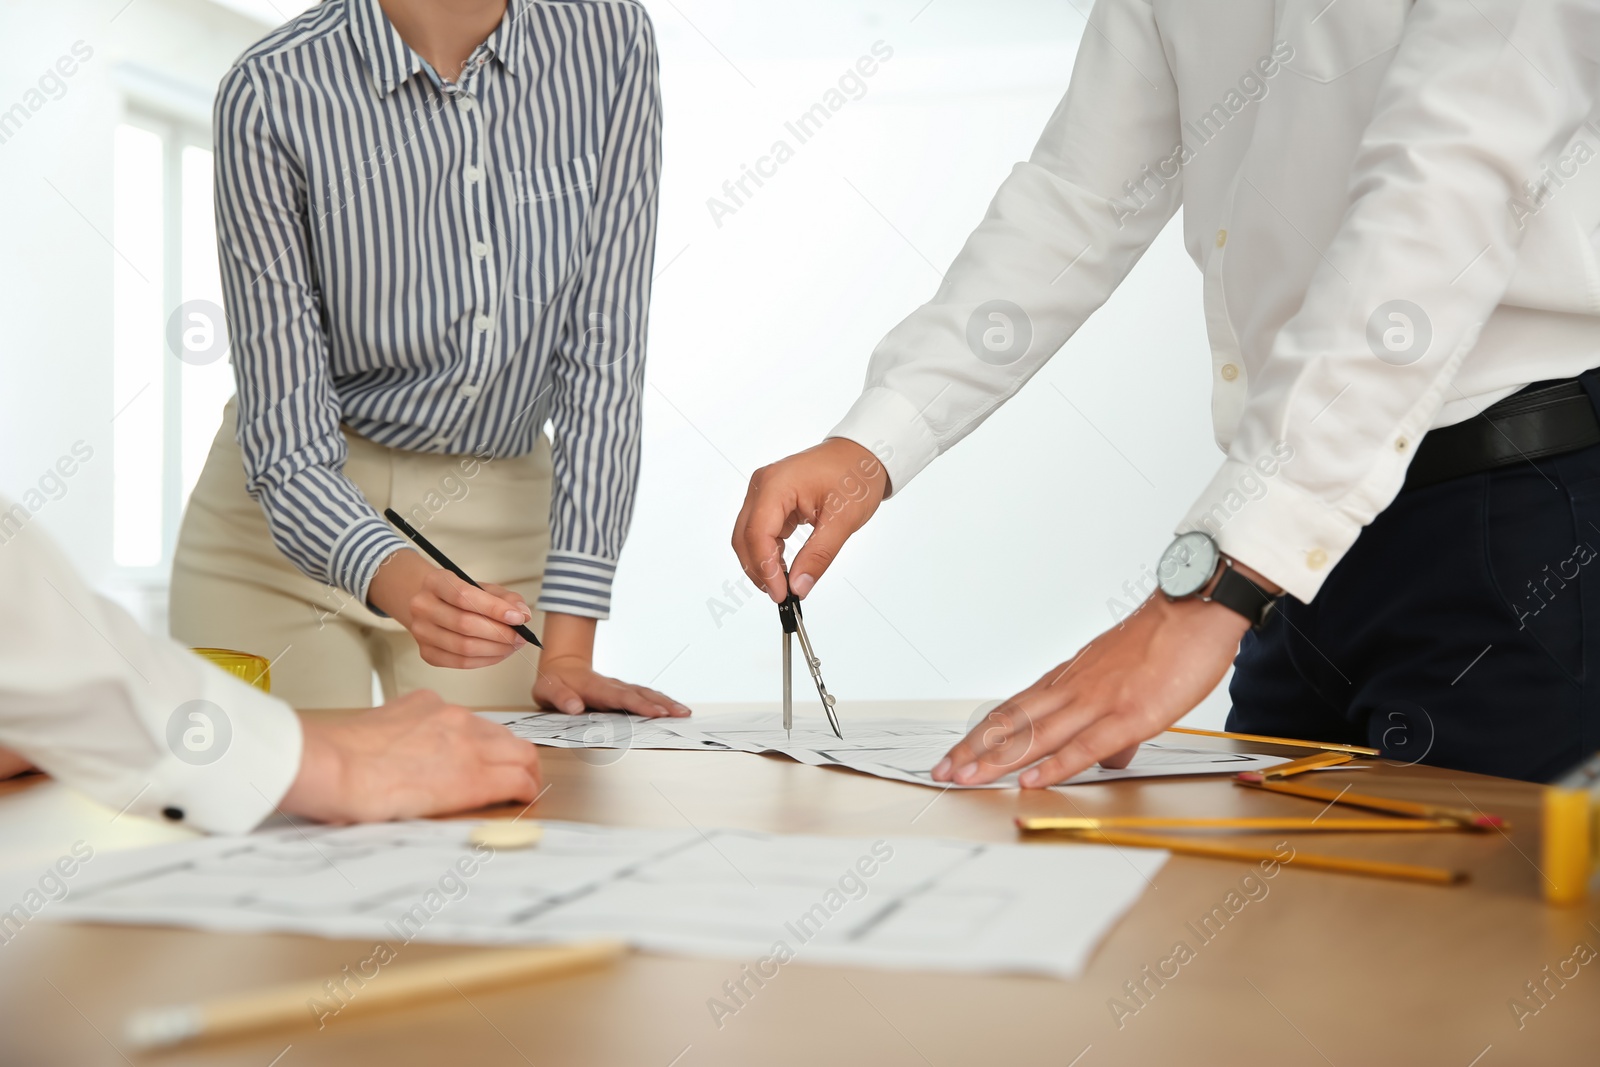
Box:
[125,941,627,1049]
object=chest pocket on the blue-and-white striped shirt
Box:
[507,152,598,313]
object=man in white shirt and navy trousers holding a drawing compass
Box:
[734,0,1600,785]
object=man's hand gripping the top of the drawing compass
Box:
[733,437,890,603]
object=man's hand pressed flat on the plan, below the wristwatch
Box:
[933,592,1250,789]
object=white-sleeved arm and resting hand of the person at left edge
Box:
[0,498,539,833]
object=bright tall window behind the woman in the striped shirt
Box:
[112,112,234,582]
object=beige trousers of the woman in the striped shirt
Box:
[171,400,550,707]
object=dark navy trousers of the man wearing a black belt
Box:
[1227,395,1600,781]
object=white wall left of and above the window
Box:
[0,0,266,584]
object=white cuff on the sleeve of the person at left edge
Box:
[126,662,304,833]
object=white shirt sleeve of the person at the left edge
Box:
[0,498,301,833]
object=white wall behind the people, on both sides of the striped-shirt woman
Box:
[0,0,1226,721]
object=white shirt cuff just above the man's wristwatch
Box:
[1176,459,1362,603]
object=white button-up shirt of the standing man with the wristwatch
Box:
[832,0,1600,601]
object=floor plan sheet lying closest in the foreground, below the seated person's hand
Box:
[28,821,1166,995]
